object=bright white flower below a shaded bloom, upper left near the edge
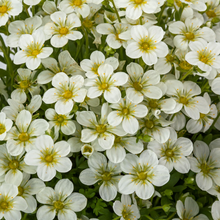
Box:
[14,28,53,70]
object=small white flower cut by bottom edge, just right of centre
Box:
[113,195,140,220]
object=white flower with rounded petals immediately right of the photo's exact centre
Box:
[108,98,148,134]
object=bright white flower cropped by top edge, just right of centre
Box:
[115,0,158,20]
